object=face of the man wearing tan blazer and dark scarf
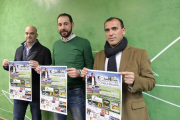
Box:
[104,19,126,48]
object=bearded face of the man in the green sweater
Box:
[57,16,74,38]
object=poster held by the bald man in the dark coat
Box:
[9,61,32,101]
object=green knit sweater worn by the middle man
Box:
[52,36,94,88]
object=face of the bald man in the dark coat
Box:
[25,26,38,44]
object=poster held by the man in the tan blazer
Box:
[86,70,122,120]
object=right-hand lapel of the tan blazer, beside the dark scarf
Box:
[119,45,131,72]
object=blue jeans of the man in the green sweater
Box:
[55,88,85,120]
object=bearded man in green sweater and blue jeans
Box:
[52,13,94,120]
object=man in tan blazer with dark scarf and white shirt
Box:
[81,17,155,120]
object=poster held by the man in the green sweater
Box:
[40,66,67,115]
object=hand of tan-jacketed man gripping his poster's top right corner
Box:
[120,72,135,85]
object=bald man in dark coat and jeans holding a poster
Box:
[2,26,52,120]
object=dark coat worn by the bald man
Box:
[4,41,52,100]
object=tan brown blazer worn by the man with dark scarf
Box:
[93,46,155,120]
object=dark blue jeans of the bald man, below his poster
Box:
[13,100,41,120]
